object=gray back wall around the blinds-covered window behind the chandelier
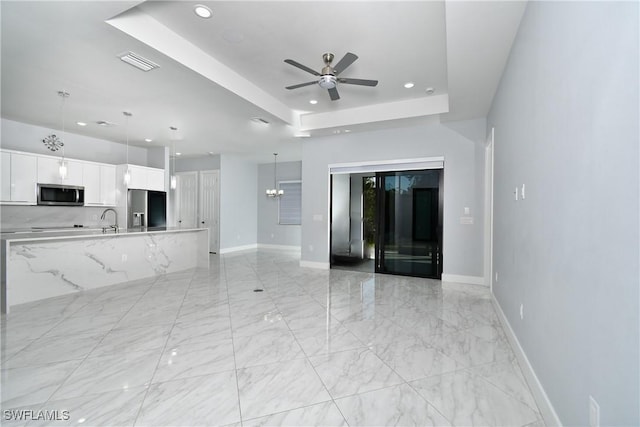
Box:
[257,162,302,247]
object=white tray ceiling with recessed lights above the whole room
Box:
[0,1,526,162]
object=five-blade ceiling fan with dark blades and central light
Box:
[284,52,378,101]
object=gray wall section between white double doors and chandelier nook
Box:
[220,154,258,251]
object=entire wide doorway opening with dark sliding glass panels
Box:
[330,168,444,279]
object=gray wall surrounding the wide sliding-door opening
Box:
[302,120,486,277]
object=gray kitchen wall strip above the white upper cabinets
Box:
[0,119,148,167]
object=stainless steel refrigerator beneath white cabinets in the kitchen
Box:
[127,190,167,228]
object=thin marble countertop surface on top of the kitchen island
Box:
[0,227,206,242]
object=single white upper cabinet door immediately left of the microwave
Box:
[8,153,38,205]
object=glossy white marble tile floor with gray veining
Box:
[0,250,544,426]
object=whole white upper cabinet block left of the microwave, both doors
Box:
[0,151,38,205]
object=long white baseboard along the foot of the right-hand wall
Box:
[491,294,562,426]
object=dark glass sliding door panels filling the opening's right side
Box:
[376,169,443,279]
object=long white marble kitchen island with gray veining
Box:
[0,228,209,313]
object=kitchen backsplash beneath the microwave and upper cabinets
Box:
[0,205,121,230]
